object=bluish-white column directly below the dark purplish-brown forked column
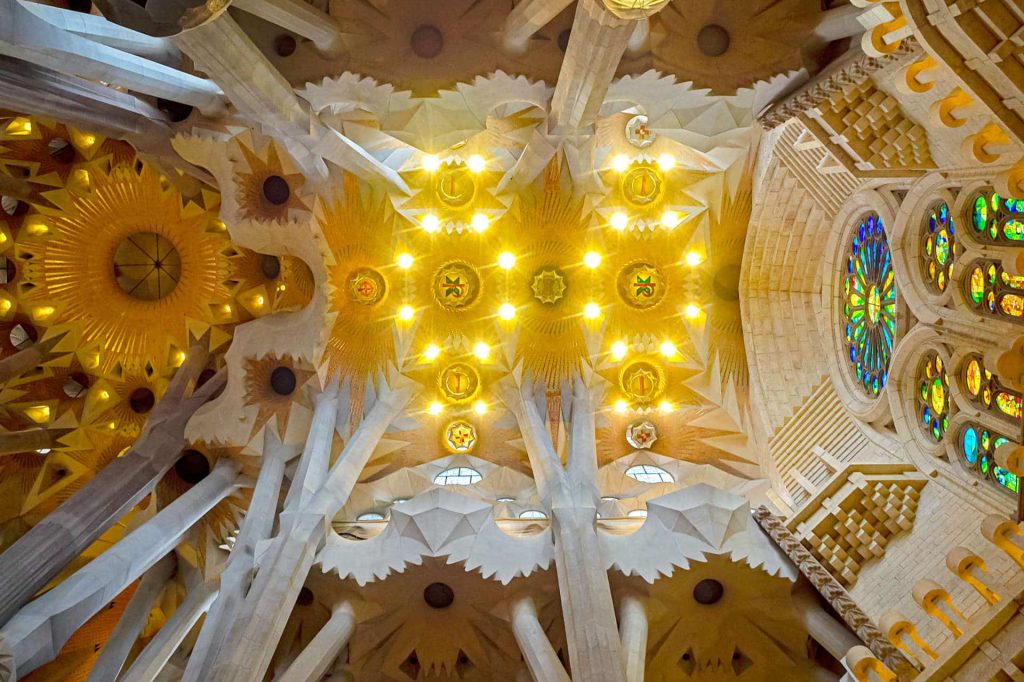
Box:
[0,459,239,676]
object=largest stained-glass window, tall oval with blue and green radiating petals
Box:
[844,213,896,395]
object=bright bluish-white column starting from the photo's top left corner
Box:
[0,0,223,115]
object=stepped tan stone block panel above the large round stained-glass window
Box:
[815,78,935,171]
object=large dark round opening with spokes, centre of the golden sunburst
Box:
[114,232,181,301]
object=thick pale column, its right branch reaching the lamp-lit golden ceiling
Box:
[207,376,414,682]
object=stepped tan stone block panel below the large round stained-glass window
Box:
[797,469,927,587]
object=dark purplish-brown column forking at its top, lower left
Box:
[0,345,225,624]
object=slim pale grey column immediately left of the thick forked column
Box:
[182,428,290,682]
